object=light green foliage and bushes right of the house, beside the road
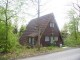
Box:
[64,10,80,46]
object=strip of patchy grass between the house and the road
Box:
[0,46,64,60]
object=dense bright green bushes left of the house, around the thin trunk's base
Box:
[0,23,19,52]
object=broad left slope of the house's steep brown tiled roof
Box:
[25,13,54,36]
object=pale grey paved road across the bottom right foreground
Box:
[18,48,80,60]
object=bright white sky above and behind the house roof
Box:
[19,0,76,30]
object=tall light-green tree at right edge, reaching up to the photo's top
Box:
[65,0,80,46]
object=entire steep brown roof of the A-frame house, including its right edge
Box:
[20,13,61,43]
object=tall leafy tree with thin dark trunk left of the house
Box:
[0,0,27,52]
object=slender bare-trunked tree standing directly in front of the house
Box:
[31,0,50,51]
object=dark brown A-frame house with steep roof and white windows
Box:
[20,13,63,46]
